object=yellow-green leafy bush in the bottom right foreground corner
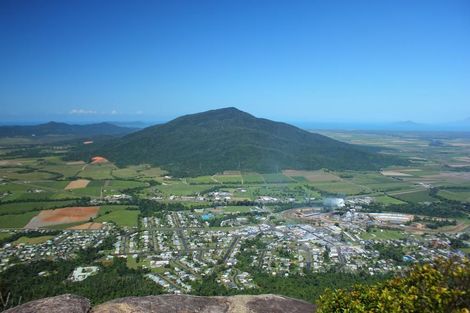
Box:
[318,260,470,313]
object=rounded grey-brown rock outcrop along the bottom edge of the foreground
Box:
[6,295,315,313]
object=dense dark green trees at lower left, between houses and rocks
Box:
[0,238,162,306]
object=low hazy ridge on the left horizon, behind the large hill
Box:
[0,122,134,137]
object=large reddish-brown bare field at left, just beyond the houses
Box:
[24,206,100,228]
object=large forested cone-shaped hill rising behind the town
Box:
[70,108,406,176]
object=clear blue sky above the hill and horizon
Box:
[0,0,470,123]
